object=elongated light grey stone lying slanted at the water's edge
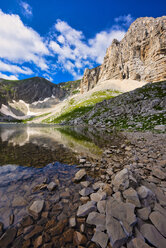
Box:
[77,201,97,217]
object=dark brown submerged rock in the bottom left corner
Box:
[0,228,17,248]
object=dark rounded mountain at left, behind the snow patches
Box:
[0,77,66,106]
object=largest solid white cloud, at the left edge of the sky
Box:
[0,10,49,70]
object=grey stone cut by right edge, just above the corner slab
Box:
[149,211,166,237]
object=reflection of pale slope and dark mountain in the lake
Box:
[0,125,104,167]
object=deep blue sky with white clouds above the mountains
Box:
[0,0,166,84]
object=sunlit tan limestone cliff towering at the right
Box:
[81,16,166,92]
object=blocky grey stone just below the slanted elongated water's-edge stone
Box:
[86,212,105,226]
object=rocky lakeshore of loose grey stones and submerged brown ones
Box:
[0,132,166,248]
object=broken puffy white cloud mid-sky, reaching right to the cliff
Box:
[49,20,125,78]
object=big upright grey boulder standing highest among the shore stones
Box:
[112,168,129,192]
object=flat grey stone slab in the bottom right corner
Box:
[140,224,166,248]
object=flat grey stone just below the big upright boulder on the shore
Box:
[123,188,141,208]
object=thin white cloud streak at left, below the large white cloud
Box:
[0,60,33,75]
